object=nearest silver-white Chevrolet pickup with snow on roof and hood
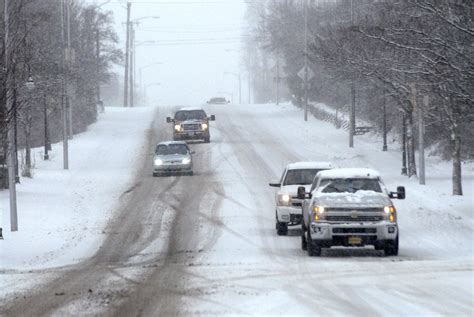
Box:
[298,168,405,256]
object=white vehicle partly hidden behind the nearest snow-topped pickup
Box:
[270,162,331,235]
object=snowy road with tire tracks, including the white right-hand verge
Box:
[1,105,474,316]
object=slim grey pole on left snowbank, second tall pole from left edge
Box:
[61,0,69,170]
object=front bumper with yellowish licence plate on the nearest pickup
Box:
[309,221,398,247]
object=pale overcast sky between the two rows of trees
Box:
[86,0,247,105]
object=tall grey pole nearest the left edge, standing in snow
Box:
[3,0,18,231]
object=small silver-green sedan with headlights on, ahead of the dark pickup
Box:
[153,141,194,176]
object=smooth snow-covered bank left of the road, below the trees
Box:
[0,108,154,274]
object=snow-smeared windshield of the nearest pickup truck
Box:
[320,178,382,193]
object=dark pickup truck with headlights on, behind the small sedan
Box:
[166,108,216,143]
